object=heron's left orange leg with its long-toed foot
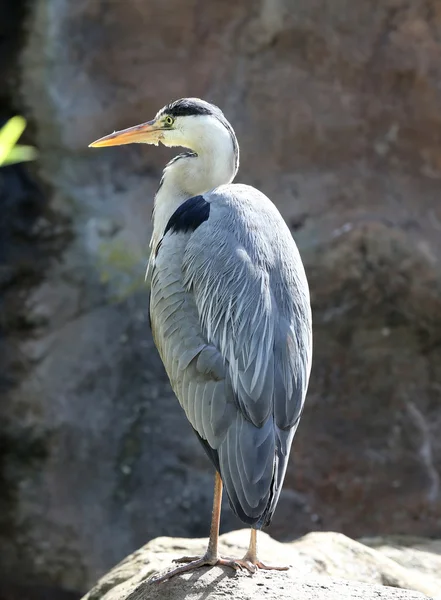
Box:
[150,471,248,583]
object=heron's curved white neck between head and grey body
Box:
[150,126,239,249]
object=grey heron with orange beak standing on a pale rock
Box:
[91,98,312,581]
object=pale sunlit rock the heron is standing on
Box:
[83,530,434,600]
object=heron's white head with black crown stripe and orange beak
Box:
[90,98,238,159]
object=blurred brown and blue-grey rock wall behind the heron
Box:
[0,0,441,598]
